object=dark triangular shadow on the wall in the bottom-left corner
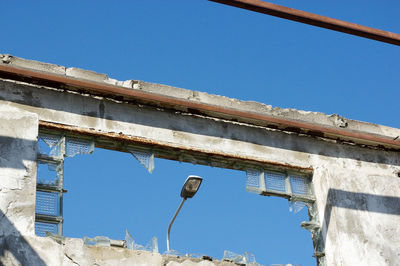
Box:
[0,210,46,266]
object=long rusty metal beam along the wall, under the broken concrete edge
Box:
[0,62,400,149]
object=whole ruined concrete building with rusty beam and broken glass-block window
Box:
[0,55,400,265]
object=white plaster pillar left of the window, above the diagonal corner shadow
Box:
[0,105,38,235]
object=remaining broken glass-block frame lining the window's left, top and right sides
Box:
[35,131,323,262]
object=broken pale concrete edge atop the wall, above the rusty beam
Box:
[0,54,400,147]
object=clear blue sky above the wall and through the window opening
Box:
[0,0,400,265]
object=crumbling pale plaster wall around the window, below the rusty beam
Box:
[0,69,400,265]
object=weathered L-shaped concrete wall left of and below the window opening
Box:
[0,105,235,266]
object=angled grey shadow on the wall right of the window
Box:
[322,189,400,250]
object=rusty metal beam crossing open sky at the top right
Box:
[209,0,400,46]
